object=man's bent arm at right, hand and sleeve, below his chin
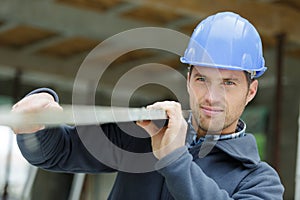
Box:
[138,102,283,199]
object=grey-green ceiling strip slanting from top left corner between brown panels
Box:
[0,0,144,39]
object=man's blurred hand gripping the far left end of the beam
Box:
[11,93,62,134]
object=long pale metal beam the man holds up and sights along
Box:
[0,105,190,127]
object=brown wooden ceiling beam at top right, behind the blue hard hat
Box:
[126,0,300,44]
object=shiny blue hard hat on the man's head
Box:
[180,12,267,78]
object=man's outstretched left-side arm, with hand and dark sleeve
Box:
[12,88,117,173]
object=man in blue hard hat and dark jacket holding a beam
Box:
[13,12,284,200]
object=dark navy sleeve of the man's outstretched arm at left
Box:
[17,88,151,173]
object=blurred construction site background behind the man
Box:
[0,0,300,200]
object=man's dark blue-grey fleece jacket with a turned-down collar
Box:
[17,89,284,200]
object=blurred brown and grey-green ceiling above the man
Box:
[0,0,300,106]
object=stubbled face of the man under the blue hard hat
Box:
[187,66,258,135]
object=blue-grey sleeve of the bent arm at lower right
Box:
[156,147,283,200]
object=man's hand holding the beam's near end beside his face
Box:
[137,101,187,159]
